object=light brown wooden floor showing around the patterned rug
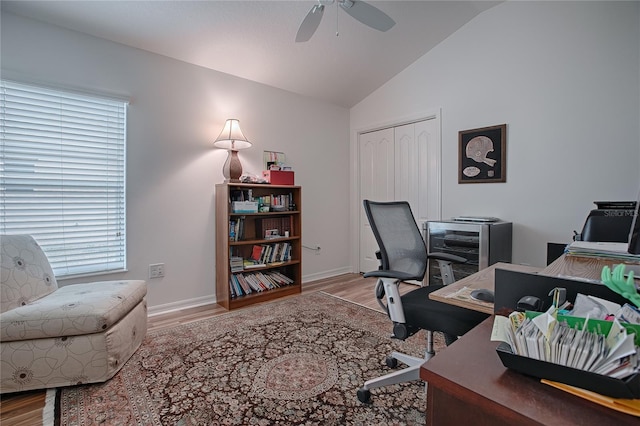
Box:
[0,274,415,426]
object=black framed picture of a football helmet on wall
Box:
[458,124,507,183]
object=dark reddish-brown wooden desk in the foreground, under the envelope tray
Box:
[420,317,640,426]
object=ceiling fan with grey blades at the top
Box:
[296,0,396,43]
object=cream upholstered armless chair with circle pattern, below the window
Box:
[0,235,147,393]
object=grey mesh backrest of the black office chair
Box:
[363,200,427,281]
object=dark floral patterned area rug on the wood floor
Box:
[57,293,443,426]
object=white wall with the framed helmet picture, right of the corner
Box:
[350,1,640,266]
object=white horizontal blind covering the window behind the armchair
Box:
[0,81,127,278]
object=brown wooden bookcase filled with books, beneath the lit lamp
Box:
[215,183,302,309]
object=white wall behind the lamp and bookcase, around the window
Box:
[1,13,350,312]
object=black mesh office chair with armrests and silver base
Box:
[357,200,488,402]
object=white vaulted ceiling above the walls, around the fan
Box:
[1,0,499,108]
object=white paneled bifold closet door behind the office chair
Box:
[358,118,441,272]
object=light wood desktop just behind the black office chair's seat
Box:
[429,262,541,315]
